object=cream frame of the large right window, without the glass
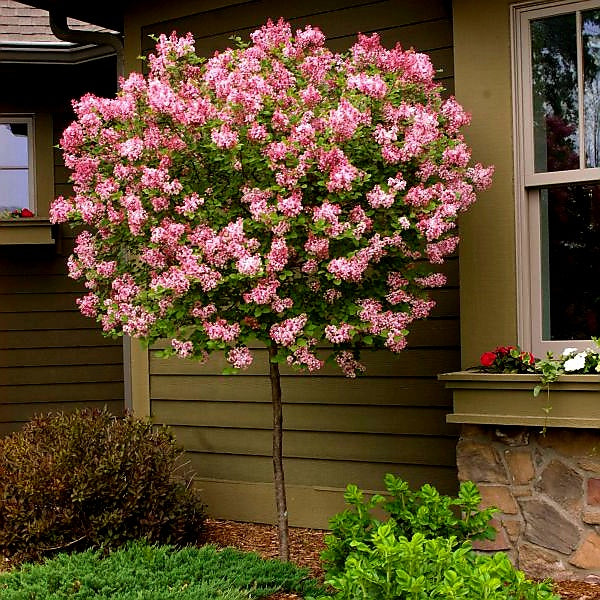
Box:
[511,0,600,357]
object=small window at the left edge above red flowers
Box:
[0,116,36,212]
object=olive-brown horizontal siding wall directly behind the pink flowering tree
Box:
[125,0,459,526]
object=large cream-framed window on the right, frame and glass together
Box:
[513,1,600,356]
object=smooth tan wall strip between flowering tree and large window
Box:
[452,0,516,367]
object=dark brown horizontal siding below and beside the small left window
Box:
[0,118,123,435]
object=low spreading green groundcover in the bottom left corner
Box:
[0,541,319,600]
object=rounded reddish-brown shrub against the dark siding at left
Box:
[0,410,204,560]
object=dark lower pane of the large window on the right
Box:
[540,185,600,340]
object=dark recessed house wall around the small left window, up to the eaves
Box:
[0,60,123,434]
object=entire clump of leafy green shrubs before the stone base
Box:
[313,474,558,600]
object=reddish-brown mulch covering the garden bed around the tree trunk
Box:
[200,519,600,600]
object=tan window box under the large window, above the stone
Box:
[438,371,600,429]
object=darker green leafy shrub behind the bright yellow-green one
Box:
[322,473,497,575]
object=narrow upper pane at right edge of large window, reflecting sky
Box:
[581,10,600,167]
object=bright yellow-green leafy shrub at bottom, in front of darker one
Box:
[310,522,558,600]
